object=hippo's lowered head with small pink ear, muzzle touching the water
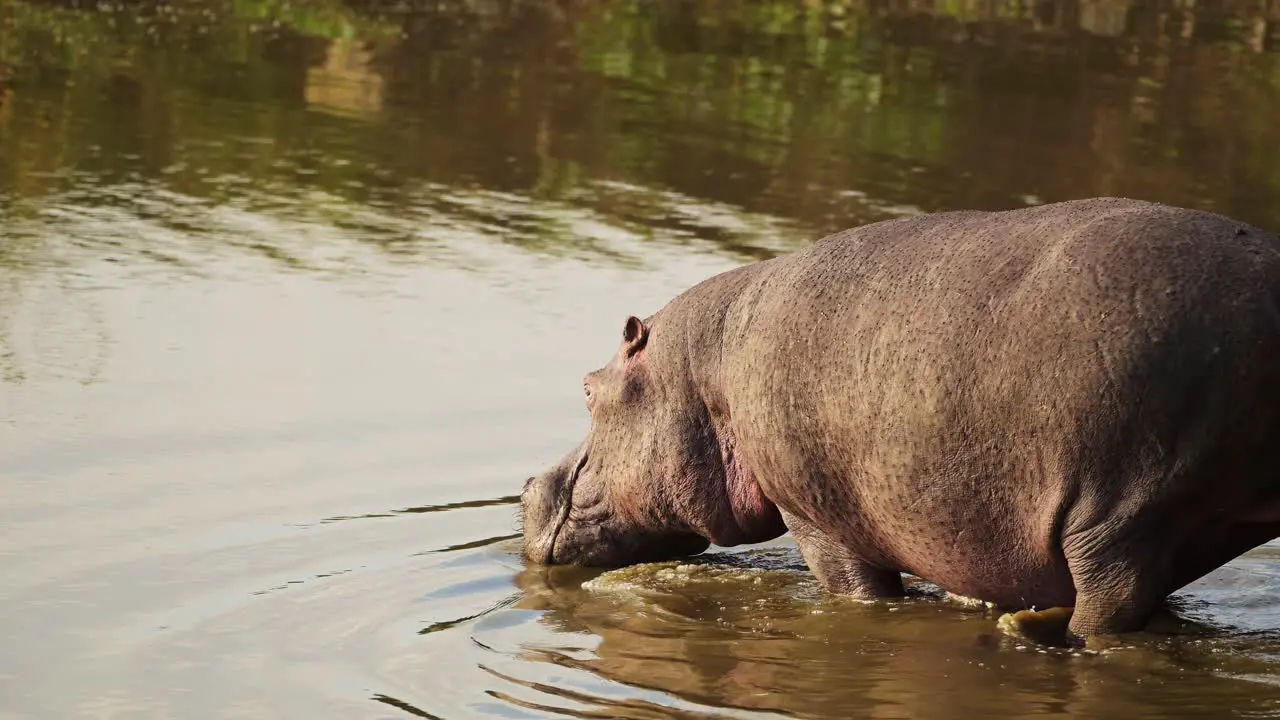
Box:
[521,316,786,568]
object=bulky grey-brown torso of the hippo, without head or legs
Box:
[724,199,1280,604]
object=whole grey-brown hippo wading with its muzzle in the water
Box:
[520,197,1280,643]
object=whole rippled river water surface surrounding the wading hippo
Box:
[0,0,1280,720]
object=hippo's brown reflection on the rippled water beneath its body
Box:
[517,553,1280,717]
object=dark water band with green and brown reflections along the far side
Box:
[0,0,1280,271]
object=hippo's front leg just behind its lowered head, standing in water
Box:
[780,509,906,600]
